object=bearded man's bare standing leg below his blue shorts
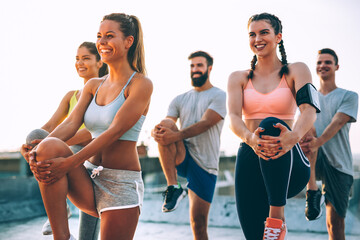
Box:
[189,189,210,240]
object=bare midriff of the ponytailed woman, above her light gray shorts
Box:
[89,140,141,171]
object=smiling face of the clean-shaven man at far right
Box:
[316,53,339,80]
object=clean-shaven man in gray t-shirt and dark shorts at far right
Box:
[301,48,358,240]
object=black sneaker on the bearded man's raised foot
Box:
[162,186,186,212]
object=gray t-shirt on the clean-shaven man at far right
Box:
[315,88,358,175]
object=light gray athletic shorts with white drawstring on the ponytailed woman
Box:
[84,161,144,215]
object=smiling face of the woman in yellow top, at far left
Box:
[75,47,102,80]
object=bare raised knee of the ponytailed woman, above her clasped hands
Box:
[36,137,72,161]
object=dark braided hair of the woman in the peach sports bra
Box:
[248,13,289,79]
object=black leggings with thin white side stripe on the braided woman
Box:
[235,117,310,240]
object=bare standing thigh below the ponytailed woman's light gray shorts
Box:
[100,207,140,240]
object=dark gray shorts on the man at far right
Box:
[315,147,353,218]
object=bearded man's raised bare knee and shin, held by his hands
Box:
[158,119,185,186]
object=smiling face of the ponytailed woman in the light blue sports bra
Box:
[96,20,134,63]
